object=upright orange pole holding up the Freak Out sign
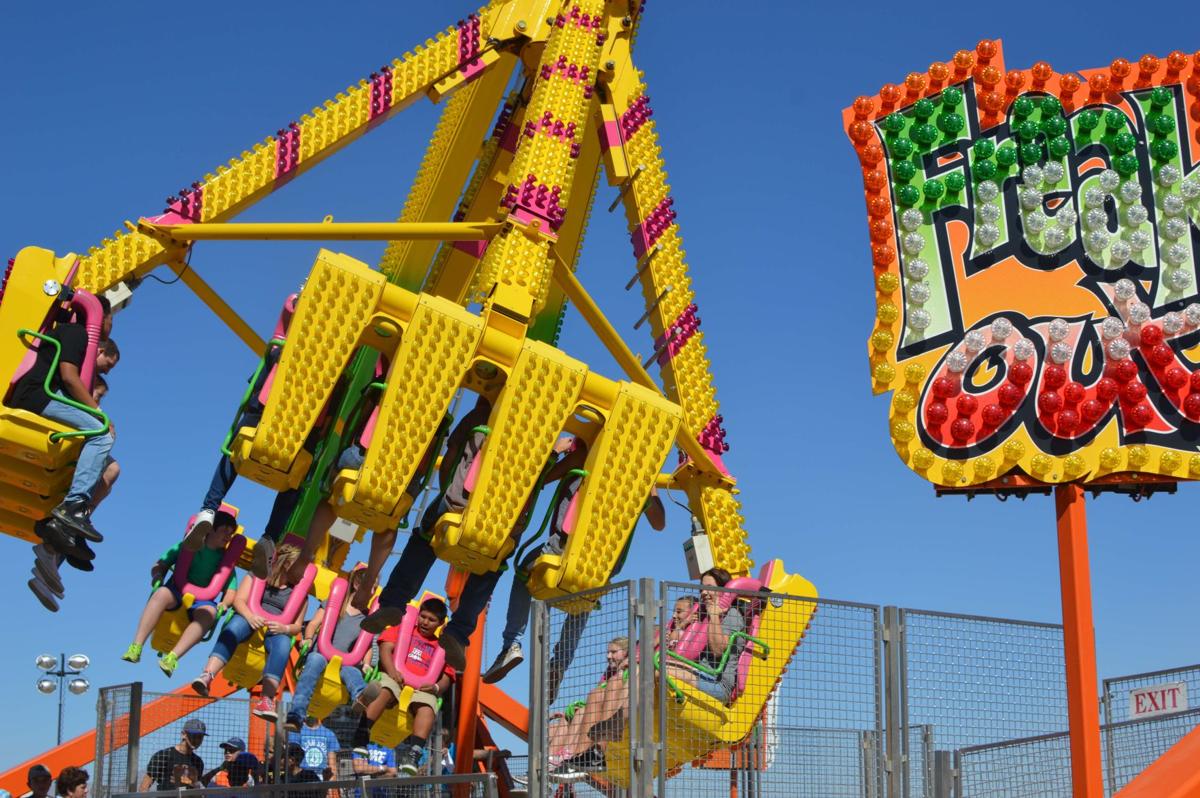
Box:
[1055,485,1104,798]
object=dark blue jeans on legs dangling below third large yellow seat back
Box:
[379,499,516,646]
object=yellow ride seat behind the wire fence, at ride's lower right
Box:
[606,559,817,786]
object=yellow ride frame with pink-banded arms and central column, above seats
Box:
[14,0,768,574]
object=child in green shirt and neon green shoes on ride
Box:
[121,512,238,676]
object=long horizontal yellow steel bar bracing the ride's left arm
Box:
[138,221,503,242]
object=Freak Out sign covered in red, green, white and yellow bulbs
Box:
[844,45,1200,487]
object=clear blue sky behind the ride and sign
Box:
[0,0,1200,767]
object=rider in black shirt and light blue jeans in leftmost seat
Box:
[8,296,120,544]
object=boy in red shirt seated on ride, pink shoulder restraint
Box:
[354,599,455,775]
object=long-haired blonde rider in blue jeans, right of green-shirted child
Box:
[192,545,308,722]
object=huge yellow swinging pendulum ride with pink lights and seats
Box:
[0,0,815,790]
